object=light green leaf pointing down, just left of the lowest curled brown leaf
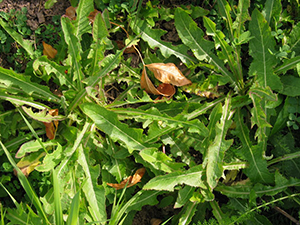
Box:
[78,145,106,221]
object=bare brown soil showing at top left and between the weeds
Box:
[0,0,176,225]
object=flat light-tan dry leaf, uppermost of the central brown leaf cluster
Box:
[145,63,192,86]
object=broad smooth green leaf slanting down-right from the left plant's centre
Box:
[80,103,148,153]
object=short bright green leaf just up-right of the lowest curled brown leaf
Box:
[139,148,185,173]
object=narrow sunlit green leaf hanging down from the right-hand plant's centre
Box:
[206,97,233,189]
